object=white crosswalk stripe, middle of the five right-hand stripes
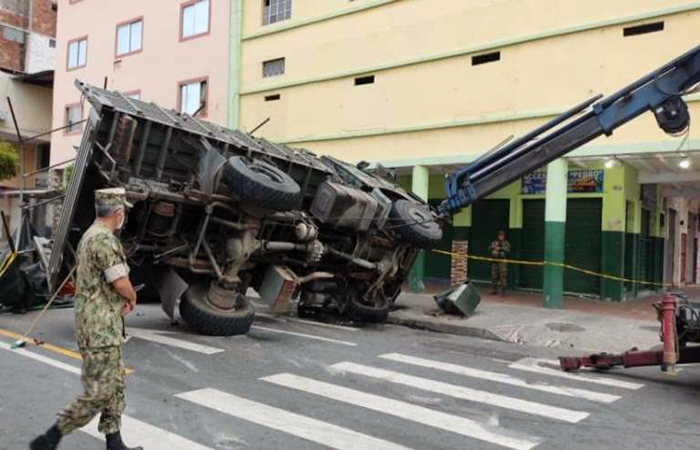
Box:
[331,362,590,423]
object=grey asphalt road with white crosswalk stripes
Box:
[0,305,700,450]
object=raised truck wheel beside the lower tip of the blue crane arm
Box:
[391,200,442,249]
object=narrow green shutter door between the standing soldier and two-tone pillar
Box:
[520,200,545,289]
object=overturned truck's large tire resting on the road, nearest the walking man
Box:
[180,284,255,336]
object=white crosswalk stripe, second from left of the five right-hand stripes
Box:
[261,373,541,450]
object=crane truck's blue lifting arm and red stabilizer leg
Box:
[440,46,700,371]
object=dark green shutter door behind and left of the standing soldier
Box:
[468,200,510,282]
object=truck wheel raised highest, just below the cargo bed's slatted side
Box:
[223,156,301,211]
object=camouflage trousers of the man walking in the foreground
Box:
[57,347,126,435]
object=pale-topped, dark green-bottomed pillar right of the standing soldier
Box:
[543,159,569,309]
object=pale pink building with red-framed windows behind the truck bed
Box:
[51,0,235,167]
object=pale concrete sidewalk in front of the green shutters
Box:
[388,288,680,352]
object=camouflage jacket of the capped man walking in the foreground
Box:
[75,221,129,349]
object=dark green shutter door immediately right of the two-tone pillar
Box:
[564,198,603,295]
